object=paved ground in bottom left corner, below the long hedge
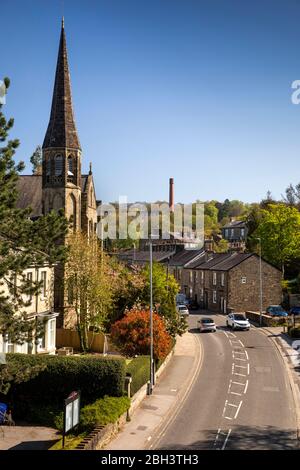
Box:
[0,426,60,450]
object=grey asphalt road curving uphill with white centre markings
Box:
[155,314,297,450]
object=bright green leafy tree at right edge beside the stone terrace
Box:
[252,204,300,277]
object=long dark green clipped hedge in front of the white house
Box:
[7,354,125,406]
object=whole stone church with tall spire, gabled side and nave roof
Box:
[18,20,97,326]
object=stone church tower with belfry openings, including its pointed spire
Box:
[42,20,81,230]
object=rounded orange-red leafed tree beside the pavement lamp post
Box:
[111,308,172,360]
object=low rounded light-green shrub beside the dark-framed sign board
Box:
[80,397,130,430]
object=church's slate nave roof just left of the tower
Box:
[17,175,42,217]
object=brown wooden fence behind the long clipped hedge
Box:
[56,328,105,353]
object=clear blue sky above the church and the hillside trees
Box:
[0,0,300,203]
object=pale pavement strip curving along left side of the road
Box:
[105,332,202,450]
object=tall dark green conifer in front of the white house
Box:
[0,79,68,344]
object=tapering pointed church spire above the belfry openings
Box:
[43,18,81,150]
